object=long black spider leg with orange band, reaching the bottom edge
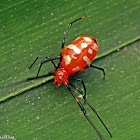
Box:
[67,86,104,140]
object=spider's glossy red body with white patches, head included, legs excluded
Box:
[53,35,99,88]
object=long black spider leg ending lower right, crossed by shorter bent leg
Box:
[69,83,112,137]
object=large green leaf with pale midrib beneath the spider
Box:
[0,0,140,140]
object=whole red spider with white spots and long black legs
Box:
[26,16,112,140]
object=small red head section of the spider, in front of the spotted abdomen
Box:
[53,68,69,88]
